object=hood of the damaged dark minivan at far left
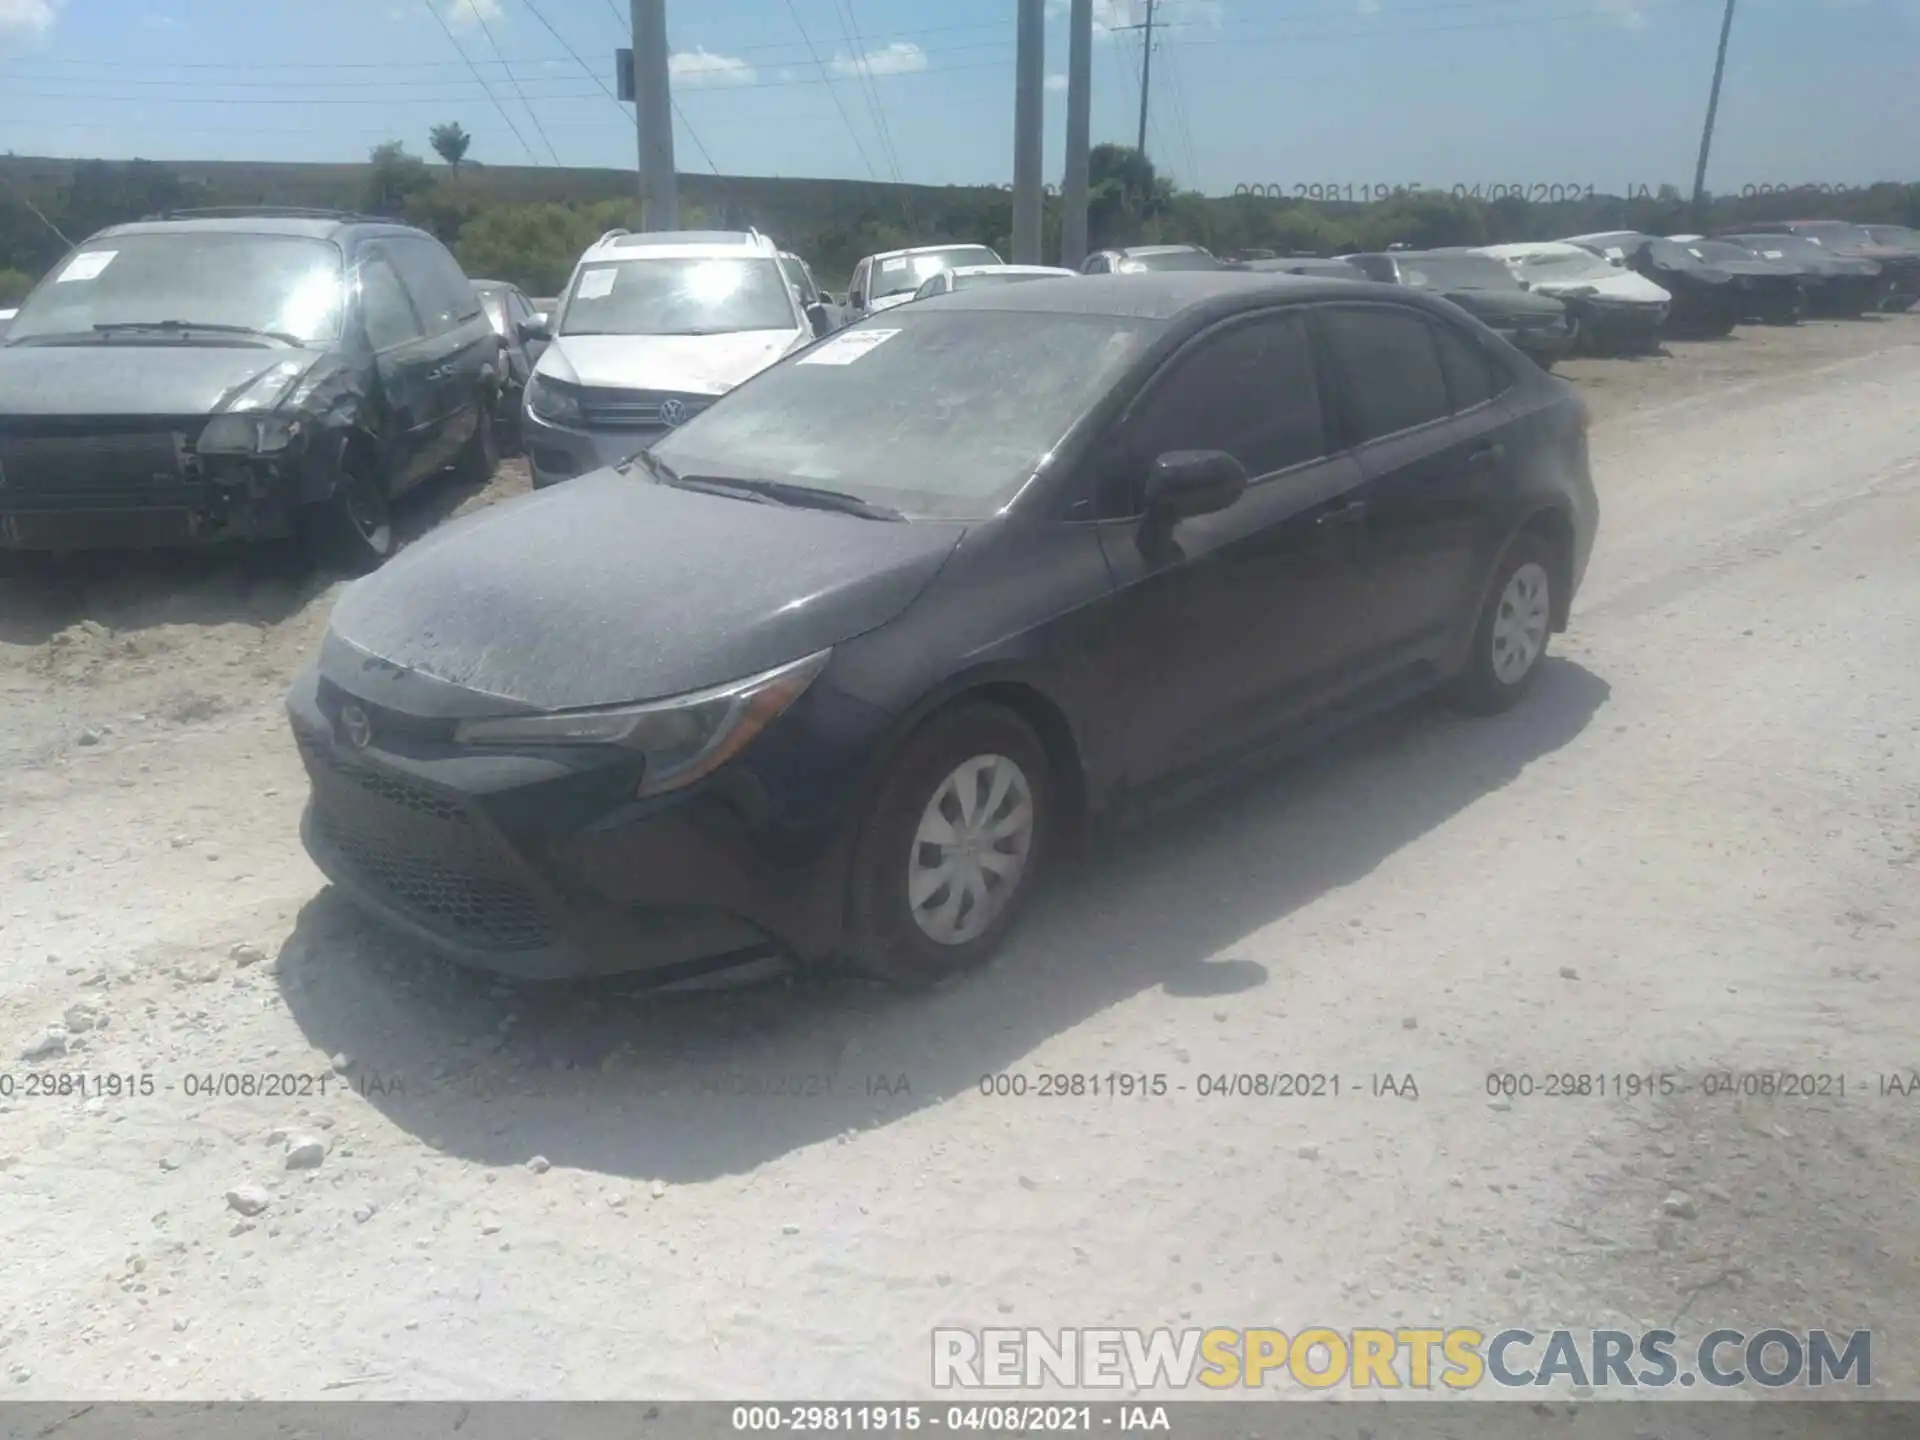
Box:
[0,342,319,417]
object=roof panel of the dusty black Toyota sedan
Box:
[914,271,1407,321]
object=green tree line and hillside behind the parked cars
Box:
[0,135,1920,305]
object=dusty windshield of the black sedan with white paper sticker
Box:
[651,307,1162,518]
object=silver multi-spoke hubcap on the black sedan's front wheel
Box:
[906,755,1033,945]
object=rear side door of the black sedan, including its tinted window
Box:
[1315,305,1513,676]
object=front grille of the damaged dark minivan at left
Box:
[0,420,202,503]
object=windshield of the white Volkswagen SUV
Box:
[559,257,799,334]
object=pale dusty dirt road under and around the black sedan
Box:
[0,319,1920,1400]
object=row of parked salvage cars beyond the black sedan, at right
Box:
[1236,221,1920,367]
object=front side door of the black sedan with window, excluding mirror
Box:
[1091,309,1363,783]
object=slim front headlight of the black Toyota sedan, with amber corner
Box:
[453,649,833,795]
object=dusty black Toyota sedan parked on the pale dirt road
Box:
[288,271,1597,983]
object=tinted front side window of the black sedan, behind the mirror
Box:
[1098,311,1327,520]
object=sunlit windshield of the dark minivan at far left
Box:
[6,228,344,346]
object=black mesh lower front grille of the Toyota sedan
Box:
[298,732,553,950]
